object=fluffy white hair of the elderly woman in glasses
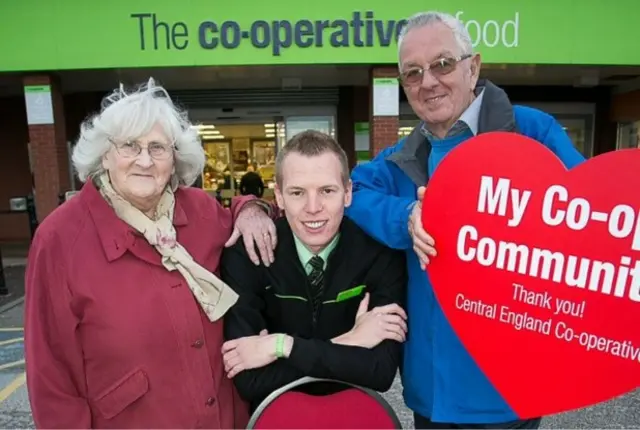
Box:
[72,78,206,186]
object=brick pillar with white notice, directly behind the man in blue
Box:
[369,66,400,157]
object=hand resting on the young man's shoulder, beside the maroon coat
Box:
[225,202,278,266]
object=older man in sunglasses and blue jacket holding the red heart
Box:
[347,12,583,428]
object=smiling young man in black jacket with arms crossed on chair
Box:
[221,131,407,410]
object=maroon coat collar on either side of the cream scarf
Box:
[81,180,189,261]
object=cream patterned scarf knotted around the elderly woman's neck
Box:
[96,173,238,321]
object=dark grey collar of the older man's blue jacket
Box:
[386,80,517,186]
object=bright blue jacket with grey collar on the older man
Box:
[346,82,584,424]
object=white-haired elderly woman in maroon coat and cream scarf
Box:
[25,80,275,428]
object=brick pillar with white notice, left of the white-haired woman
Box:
[23,75,71,221]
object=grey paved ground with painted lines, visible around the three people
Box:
[0,265,640,429]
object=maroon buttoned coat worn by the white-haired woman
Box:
[25,183,252,428]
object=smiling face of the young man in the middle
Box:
[275,151,351,254]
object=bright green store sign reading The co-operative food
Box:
[0,0,640,72]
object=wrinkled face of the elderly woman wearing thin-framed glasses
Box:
[102,125,175,212]
